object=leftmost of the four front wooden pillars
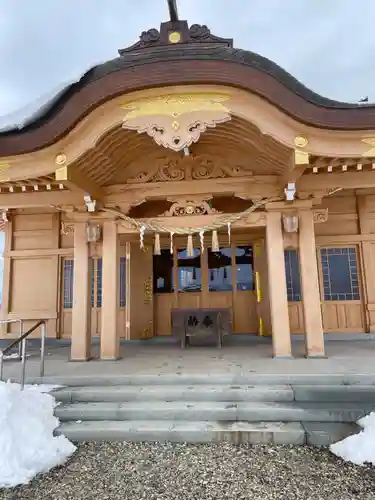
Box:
[70,222,91,361]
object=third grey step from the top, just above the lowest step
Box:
[55,401,371,422]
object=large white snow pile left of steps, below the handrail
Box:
[0,382,76,488]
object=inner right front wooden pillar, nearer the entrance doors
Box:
[266,212,292,358]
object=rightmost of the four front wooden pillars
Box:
[299,210,325,358]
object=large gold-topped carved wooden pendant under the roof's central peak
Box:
[122,93,231,151]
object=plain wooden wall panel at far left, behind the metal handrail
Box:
[1,209,60,337]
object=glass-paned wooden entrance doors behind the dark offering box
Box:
[153,241,258,336]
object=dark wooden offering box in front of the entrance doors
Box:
[171,308,232,348]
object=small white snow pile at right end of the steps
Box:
[330,413,375,465]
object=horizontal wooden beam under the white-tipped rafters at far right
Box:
[297,170,375,193]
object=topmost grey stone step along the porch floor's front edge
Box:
[33,374,375,387]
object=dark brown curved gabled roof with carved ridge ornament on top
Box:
[0,21,375,156]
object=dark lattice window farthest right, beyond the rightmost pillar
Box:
[320,247,361,300]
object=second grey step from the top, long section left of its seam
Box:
[54,385,296,403]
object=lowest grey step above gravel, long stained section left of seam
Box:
[57,420,306,445]
